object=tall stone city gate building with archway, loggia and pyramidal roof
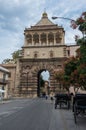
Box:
[1,12,77,97]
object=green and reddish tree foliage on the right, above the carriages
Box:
[55,12,86,90]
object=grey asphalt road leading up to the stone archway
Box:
[0,98,86,130]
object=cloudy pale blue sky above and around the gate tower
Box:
[0,0,86,63]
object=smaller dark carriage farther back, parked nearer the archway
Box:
[55,93,71,109]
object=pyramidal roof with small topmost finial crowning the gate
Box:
[35,12,55,26]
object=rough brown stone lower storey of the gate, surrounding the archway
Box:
[18,58,64,97]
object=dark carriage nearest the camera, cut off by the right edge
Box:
[73,94,86,123]
